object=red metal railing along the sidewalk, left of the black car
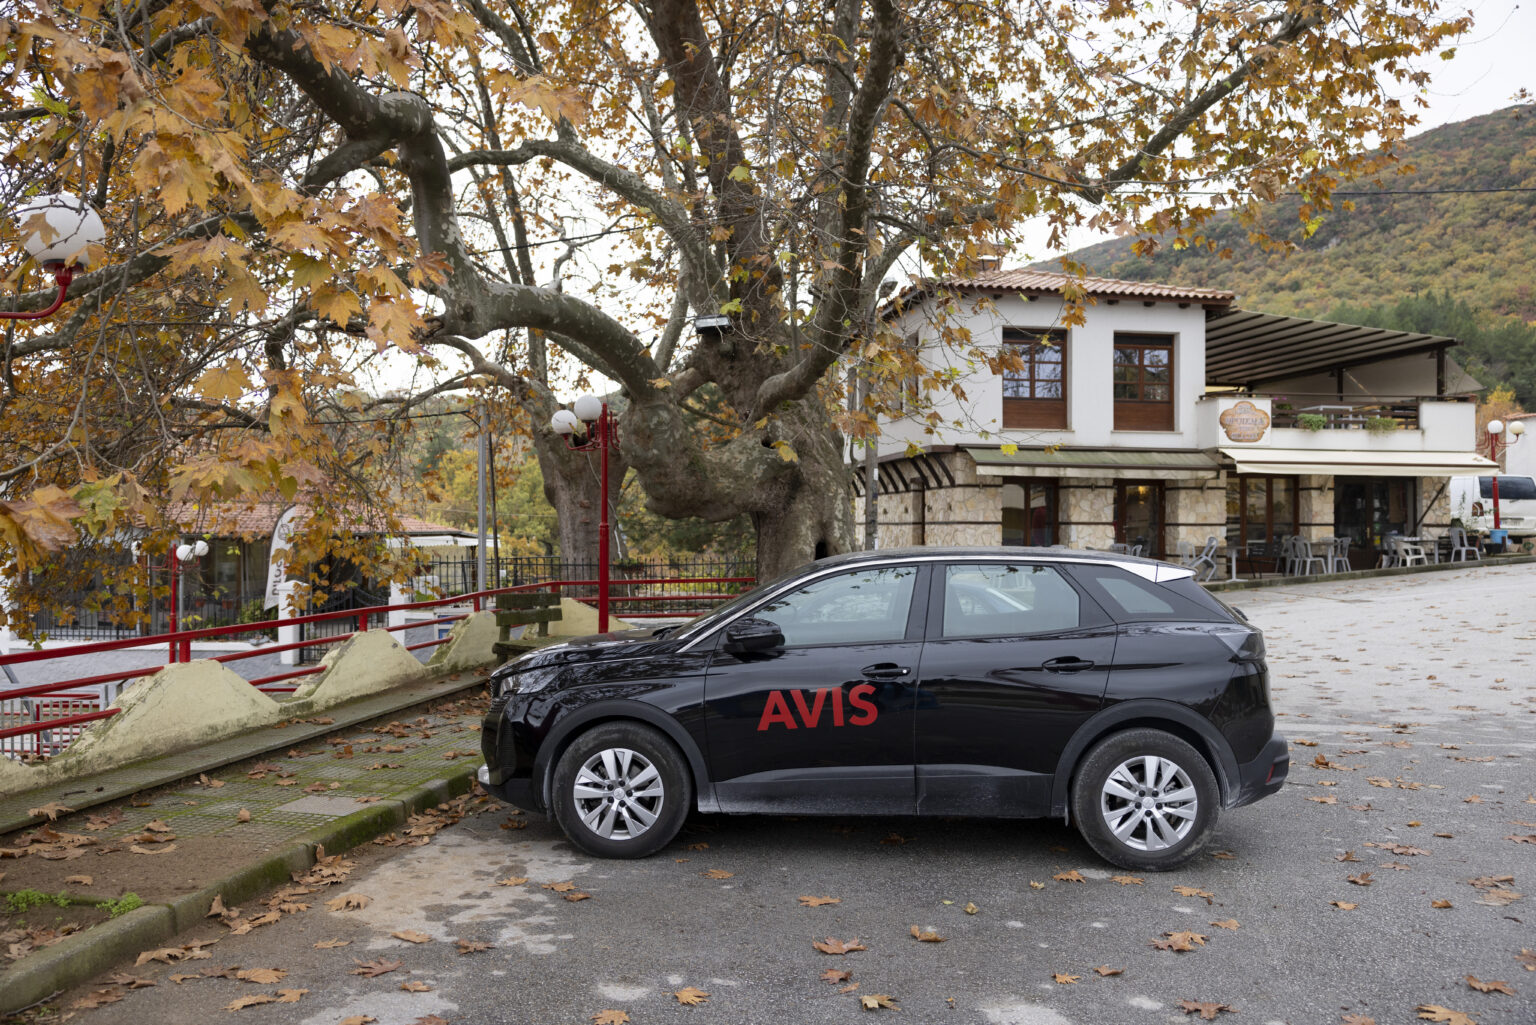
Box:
[0,576,753,758]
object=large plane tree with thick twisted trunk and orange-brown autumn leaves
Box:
[0,0,1467,583]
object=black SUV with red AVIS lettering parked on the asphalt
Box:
[479,549,1290,870]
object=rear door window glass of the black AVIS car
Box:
[940,562,1083,638]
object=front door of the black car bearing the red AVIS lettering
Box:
[705,564,928,814]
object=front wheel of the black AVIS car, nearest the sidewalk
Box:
[550,722,693,857]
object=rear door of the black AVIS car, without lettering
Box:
[915,559,1115,816]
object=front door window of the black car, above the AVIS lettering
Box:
[751,566,917,647]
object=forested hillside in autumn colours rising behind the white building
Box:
[1074,106,1536,407]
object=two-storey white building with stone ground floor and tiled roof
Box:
[854,270,1490,566]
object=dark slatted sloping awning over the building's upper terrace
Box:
[1206,309,1459,387]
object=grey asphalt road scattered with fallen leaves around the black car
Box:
[48,567,1536,1025]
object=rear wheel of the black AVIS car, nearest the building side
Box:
[1072,728,1221,871]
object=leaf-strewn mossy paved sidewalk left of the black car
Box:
[0,673,485,1013]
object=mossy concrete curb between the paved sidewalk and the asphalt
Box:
[0,759,479,1014]
